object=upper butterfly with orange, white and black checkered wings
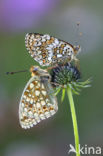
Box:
[25,33,81,66]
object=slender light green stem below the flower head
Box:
[67,87,80,156]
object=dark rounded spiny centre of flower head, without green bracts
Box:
[51,63,80,85]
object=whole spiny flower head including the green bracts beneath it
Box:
[51,63,90,101]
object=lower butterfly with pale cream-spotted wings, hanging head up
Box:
[19,66,58,129]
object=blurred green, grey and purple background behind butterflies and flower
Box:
[0,0,103,156]
